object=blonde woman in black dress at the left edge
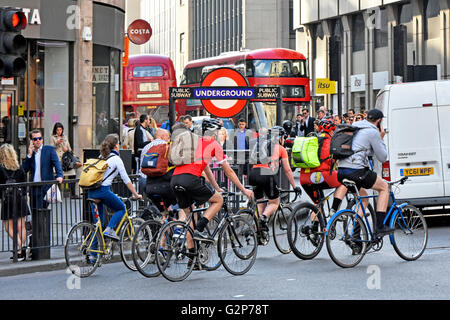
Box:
[0,144,29,261]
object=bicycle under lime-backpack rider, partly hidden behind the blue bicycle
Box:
[287,189,375,260]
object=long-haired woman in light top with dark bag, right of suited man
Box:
[50,122,81,196]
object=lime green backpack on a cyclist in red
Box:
[291,137,327,169]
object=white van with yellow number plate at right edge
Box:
[376,81,450,207]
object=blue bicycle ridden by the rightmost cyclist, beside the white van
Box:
[325,177,428,268]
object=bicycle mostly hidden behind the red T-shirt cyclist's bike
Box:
[131,204,221,278]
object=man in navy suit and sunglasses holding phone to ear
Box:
[23,129,63,209]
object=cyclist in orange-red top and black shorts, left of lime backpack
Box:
[249,126,301,231]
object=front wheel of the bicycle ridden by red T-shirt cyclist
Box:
[217,216,258,275]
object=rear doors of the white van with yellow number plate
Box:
[389,81,444,199]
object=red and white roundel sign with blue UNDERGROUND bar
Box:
[198,68,255,118]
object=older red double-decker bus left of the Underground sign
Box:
[123,54,177,125]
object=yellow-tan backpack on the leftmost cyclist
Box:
[78,154,117,190]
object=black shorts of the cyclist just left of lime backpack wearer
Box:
[248,168,280,200]
